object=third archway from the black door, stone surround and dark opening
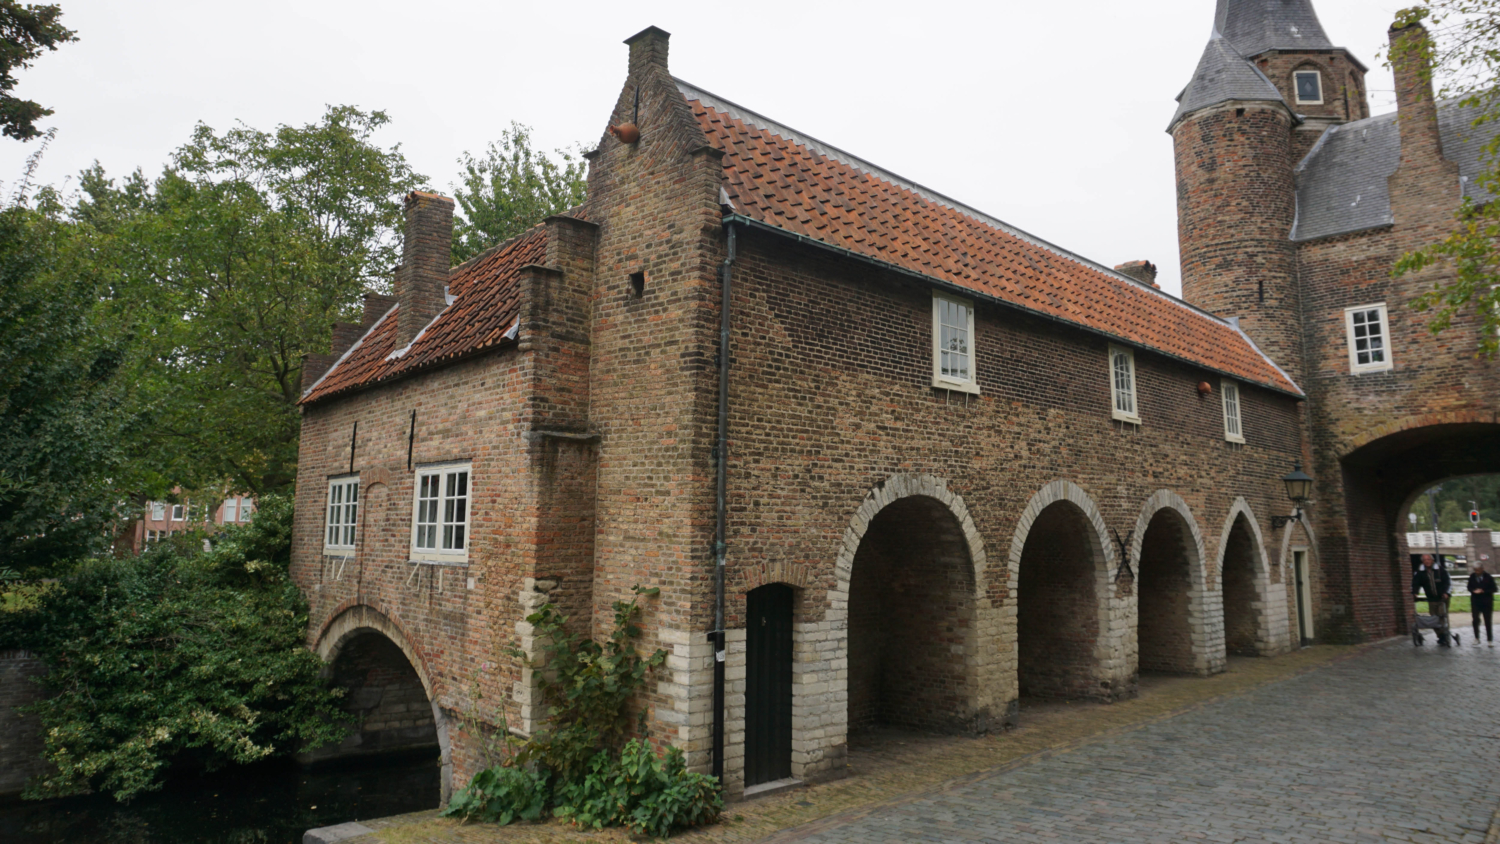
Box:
[1128,489,1224,676]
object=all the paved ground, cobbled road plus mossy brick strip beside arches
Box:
[354,641,1500,844]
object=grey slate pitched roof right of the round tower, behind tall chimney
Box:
[1292,100,1500,241]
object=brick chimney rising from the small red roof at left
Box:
[396,190,453,349]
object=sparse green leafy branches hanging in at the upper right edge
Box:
[1388,0,1500,357]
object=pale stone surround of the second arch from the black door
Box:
[1001,480,1134,702]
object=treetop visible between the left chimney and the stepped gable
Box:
[453,123,588,262]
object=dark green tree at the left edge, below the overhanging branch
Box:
[0,147,144,577]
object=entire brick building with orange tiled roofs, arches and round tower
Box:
[293,0,1500,795]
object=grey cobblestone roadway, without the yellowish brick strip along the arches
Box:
[770,641,1500,844]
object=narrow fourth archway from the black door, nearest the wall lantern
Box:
[1214,496,1292,657]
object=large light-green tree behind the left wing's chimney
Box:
[72,106,423,495]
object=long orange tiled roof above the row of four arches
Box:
[678,81,1302,396]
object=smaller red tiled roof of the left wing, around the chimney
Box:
[302,221,552,405]
